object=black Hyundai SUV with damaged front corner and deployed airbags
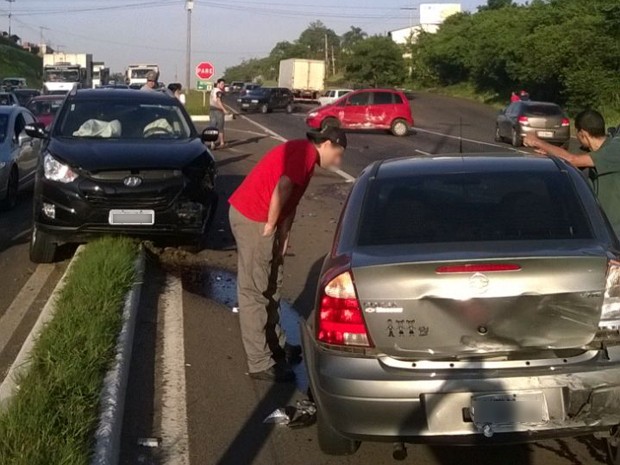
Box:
[27,89,218,263]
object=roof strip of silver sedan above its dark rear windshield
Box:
[376,152,561,179]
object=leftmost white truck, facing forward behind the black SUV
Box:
[43,53,93,94]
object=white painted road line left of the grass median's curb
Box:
[0,265,54,353]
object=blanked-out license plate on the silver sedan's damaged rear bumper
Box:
[471,392,548,425]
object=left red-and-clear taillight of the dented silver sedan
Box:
[317,271,371,347]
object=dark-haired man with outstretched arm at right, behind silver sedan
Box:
[523,110,620,232]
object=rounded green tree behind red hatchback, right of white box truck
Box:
[345,36,407,87]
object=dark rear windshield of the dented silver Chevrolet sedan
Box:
[358,172,593,246]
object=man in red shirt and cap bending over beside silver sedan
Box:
[229,127,347,382]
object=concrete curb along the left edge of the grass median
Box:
[0,246,84,410]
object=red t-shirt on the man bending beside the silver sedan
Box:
[228,139,318,223]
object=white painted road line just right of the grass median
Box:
[159,275,189,465]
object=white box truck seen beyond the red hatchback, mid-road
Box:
[278,58,325,101]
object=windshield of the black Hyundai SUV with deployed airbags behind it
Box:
[55,100,191,139]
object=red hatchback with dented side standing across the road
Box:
[306,89,413,137]
